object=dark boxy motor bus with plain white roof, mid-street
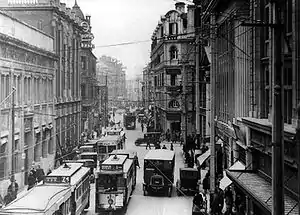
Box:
[143,149,175,197]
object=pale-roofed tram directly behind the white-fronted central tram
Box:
[97,135,125,163]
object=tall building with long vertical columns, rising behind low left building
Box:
[0,0,84,166]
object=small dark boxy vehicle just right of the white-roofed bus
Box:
[176,168,200,196]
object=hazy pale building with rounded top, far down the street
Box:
[97,56,126,107]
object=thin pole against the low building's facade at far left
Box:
[11,87,16,193]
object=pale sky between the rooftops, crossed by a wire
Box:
[61,0,184,78]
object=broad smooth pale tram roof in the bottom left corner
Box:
[0,185,71,214]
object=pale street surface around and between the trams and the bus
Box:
[87,110,192,215]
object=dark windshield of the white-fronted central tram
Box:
[98,174,125,191]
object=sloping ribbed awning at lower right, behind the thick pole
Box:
[226,170,299,215]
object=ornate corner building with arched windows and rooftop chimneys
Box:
[151,2,195,136]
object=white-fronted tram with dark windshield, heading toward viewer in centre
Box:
[95,152,136,214]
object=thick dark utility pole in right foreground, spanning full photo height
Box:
[271,1,284,215]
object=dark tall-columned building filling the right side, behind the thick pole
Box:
[200,0,300,214]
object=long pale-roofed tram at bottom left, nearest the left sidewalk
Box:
[0,163,90,215]
